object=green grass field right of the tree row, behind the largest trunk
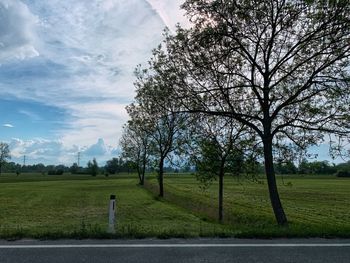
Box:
[146,174,350,238]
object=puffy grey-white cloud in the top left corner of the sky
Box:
[0,0,39,63]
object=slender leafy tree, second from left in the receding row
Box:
[127,65,186,197]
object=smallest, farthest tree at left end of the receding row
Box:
[120,121,151,185]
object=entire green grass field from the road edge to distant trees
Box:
[0,174,350,238]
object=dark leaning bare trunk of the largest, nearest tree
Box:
[263,137,288,226]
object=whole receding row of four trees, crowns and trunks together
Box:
[121,0,350,225]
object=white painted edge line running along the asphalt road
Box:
[0,243,350,249]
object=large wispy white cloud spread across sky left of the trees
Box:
[0,0,190,153]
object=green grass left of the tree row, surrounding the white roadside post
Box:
[0,174,235,239]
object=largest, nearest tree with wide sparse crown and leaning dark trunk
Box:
[157,0,350,225]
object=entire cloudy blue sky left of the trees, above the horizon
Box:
[0,0,187,164]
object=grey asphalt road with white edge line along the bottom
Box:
[0,239,350,263]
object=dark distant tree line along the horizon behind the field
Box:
[2,157,350,177]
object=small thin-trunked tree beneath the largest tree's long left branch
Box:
[191,116,250,222]
